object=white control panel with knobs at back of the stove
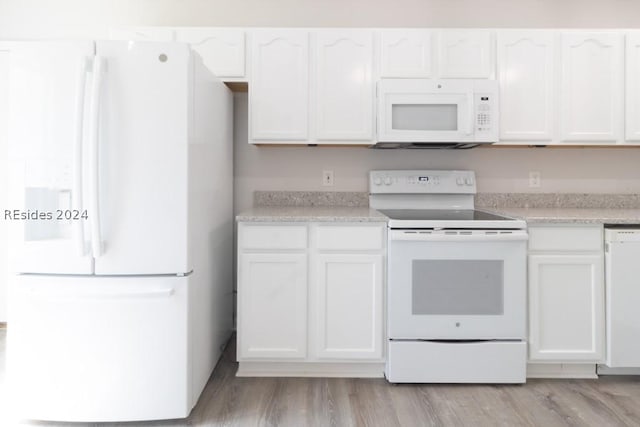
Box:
[369,170,476,194]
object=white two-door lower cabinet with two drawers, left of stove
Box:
[238,222,386,376]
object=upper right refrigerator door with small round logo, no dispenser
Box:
[93,41,192,275]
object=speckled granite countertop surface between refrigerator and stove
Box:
[236,206,387,222]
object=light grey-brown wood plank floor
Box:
[0,330,640,427]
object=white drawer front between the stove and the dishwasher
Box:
[529,226,602,251]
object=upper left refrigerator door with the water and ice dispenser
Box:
[3,42,94,274]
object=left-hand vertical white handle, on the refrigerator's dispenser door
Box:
[71,57,89,255]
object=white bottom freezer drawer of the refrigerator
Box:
[7,276,191,422]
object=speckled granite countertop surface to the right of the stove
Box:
[478,207,640,224]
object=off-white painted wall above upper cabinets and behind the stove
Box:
[0,0,640,321]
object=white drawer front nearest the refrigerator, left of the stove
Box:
[240,225,307,249]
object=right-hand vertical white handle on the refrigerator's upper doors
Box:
[88,55,104,258]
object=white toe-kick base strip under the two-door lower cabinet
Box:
[236,362,384,378]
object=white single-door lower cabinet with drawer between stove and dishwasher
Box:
[529,225,604,363]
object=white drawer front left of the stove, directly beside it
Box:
[316,226,384,250]
